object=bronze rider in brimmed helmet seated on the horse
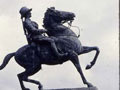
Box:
[19,7,67,57]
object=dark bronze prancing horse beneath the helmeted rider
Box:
[0,7,99,90]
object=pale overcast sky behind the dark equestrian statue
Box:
[0,0,119,90]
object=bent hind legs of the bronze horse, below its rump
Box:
[18,69,42,90]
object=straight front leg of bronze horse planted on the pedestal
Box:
[70,52,93,87]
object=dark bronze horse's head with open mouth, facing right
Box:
[43,7,75,25]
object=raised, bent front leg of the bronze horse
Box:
[80,46,100,69]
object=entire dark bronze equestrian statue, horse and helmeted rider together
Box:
[0,7,100,90]
